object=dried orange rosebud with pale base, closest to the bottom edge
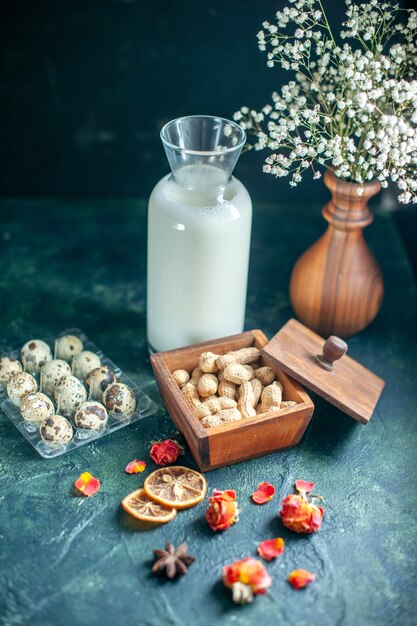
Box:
[222,557,272,603]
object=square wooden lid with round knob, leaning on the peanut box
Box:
[262,319,385,424]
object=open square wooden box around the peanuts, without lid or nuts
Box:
[151,330,314,471]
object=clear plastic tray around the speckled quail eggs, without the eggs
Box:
[0,328,158,459]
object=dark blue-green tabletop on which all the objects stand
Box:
[0,199,417,626]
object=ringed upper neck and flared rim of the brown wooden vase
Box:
[322,170,381,231]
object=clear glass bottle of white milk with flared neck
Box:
[147,115,252,352]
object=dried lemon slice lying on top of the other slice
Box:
[143,465,207,509]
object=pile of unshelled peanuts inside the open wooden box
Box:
[172,348,296,428]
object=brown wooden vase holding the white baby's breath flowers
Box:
[290,170,384,337]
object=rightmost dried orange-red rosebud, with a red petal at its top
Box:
[279,480,324,534]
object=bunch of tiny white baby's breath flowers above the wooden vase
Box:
[234,0,417,202]
